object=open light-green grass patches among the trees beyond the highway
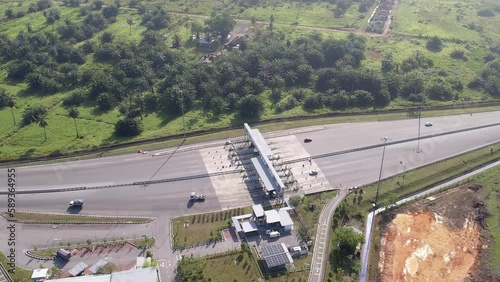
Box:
[0,0,494,159]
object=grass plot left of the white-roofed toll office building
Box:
[172,207,251,247]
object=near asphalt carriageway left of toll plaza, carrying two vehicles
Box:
[8,176,222,217]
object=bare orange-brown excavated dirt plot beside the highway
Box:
[379,184,494,282]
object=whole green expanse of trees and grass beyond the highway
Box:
[0,0,500,159]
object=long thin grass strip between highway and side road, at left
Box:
[2,212,152,224]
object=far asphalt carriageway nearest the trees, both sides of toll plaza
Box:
[5,112,500,190]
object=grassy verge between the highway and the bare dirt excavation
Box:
[329,143,500,279]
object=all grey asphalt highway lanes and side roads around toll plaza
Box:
[0,112,500,282]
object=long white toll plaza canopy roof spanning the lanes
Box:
[244,123,285,192]
